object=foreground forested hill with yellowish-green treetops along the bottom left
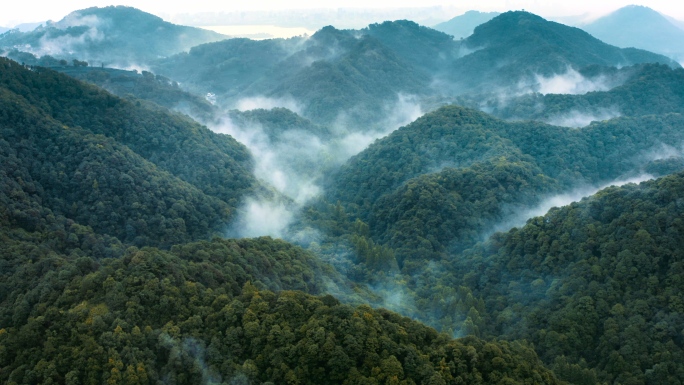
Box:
[0,239,561,384]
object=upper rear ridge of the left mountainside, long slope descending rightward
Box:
[0,59,261,207]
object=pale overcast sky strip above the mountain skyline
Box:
[0,0,684,27]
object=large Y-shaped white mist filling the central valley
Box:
[209,95,423,238]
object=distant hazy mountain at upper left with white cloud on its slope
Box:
[0,6,226,67]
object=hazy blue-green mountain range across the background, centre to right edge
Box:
[147,12,679,127]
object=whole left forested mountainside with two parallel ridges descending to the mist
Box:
[0,59,267,245]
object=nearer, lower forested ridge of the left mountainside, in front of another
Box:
[0,95,232,247]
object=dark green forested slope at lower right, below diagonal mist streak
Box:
[450,173,684,384]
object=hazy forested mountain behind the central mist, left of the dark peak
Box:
[153,22,432,125]
